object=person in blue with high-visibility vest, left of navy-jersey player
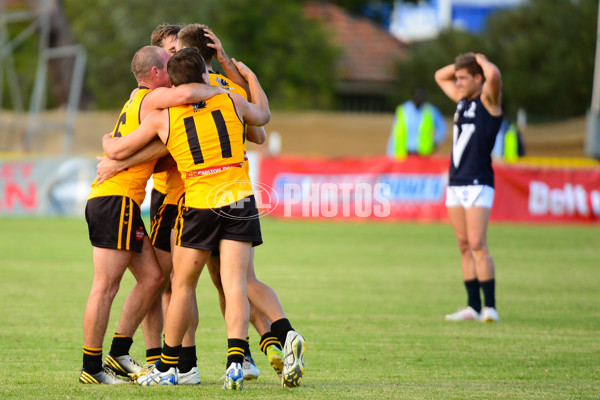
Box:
[386,87,446,160]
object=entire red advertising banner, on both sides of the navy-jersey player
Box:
[255,156,600,223]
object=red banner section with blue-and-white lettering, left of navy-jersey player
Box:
[257,157,448,221]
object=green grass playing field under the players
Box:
[0,218,600,400]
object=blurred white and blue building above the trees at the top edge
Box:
[389,0,526,42]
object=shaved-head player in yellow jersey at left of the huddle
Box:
[79,46,220,384]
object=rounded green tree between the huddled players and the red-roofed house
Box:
[208,0,338,109]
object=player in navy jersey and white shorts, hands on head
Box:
[435,53,502,322]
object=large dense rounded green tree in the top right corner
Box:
[484,0,598,117]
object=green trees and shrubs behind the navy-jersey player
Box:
[398,0,598,118]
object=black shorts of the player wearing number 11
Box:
[175,196,262,250]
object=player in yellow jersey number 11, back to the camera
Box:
[107,48,270,389]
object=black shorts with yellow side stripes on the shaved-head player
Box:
[85,196,146,252]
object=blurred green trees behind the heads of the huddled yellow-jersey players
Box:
[65,0,336,109]
